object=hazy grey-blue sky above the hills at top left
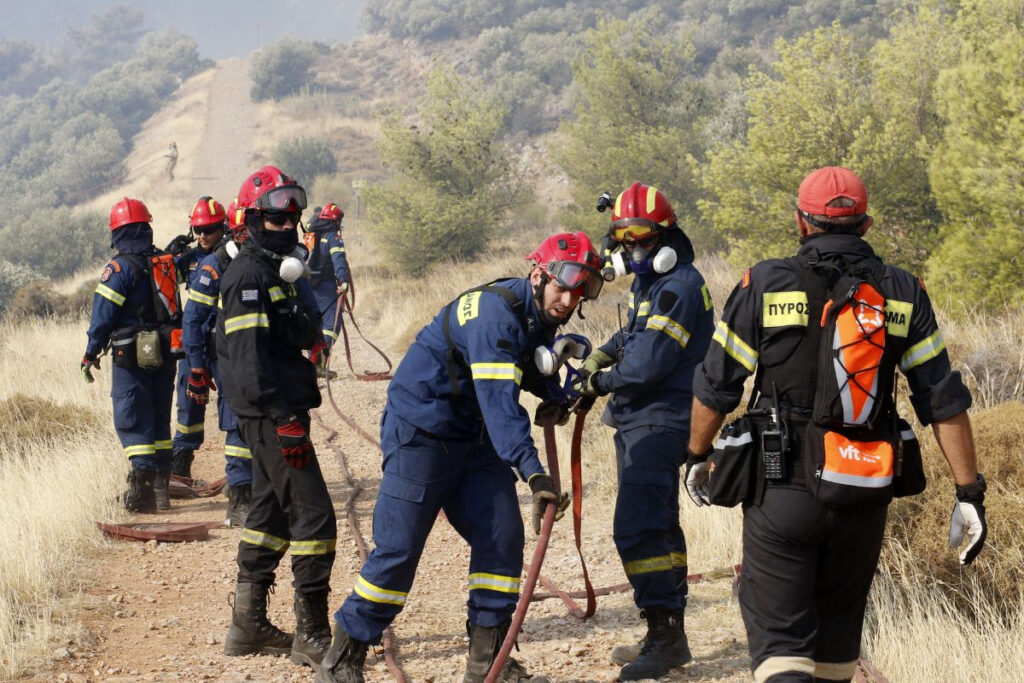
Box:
[0,0,366,59]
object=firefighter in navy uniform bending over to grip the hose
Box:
[316,232,603,683]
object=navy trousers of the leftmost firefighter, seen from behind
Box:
[111,365,174,471]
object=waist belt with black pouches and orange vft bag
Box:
[709,410,926,508]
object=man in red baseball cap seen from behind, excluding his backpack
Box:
[686,167,987,683]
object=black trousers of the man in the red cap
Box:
[739,485,887,683]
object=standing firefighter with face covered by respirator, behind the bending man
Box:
[583,182,715,681]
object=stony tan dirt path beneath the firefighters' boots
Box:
[30,368,749,682]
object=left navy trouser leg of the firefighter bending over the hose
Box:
[335,411,468,643]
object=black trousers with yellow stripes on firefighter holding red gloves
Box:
[238,413,338,593]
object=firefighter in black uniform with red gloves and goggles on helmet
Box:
[216,166,337,666]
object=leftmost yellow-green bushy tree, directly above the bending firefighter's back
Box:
[365,67,525,272]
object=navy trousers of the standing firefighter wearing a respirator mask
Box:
[612,426,688,609]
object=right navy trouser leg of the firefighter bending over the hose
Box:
[443,439,523,628]
